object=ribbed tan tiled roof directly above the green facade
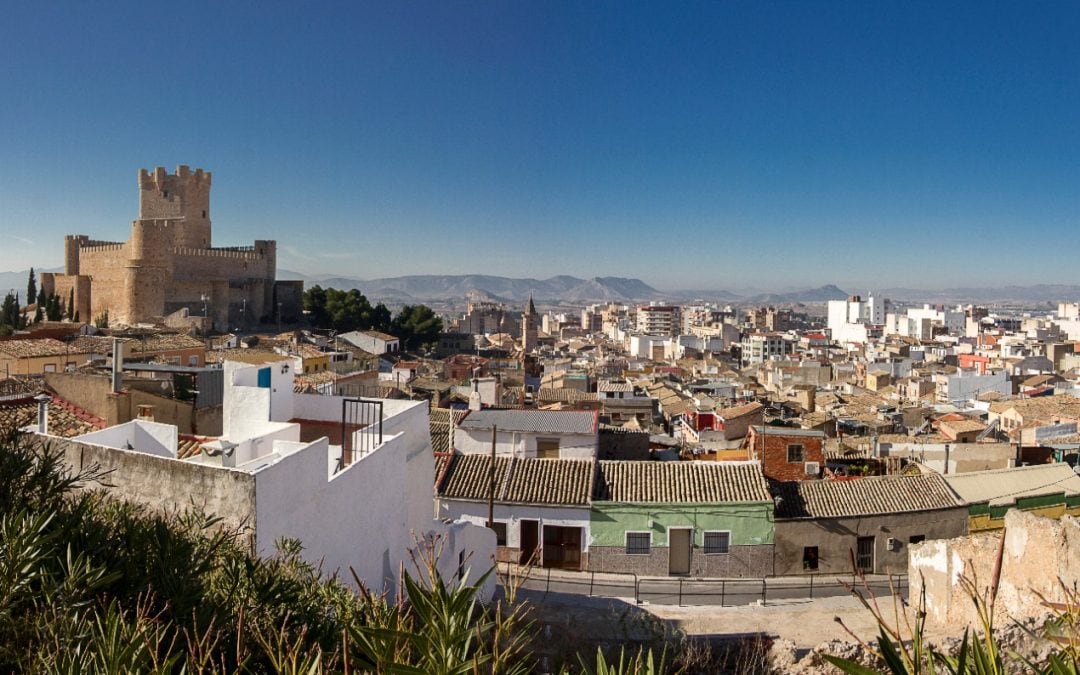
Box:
[593,460,771,503]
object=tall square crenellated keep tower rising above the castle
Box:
[138,164,211,248]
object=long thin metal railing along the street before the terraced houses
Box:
[499,565,907,607]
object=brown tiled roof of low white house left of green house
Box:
[436,455,593,505]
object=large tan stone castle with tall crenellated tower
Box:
[41,165,302,329]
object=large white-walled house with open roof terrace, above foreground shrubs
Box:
[39,362,495,595]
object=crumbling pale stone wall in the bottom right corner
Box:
[908,510,1080,632]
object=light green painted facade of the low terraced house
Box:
[589,501,773,546]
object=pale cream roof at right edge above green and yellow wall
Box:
[944,463,1080,504]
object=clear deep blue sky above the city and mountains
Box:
[0,1,1080,289]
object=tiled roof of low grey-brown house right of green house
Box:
[773,474,961,518]
